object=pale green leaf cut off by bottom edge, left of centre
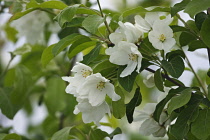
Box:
[51,127,72,140]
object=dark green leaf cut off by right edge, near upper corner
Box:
[200,16,210,48]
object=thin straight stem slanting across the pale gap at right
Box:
[182,50,208,97]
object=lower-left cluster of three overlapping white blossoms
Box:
[62,62,120,125]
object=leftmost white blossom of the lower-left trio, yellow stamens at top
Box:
[62,62,93,97]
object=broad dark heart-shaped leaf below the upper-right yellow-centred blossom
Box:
[161,56,185,78]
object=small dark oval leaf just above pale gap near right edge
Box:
[188,40,207,51]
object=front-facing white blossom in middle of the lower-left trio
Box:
[78,73,120,106]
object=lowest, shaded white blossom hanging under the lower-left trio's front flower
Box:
[74,100,110,125]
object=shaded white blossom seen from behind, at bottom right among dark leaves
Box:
[134,103,170,137]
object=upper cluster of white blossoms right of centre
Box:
[106,12,175,77]
